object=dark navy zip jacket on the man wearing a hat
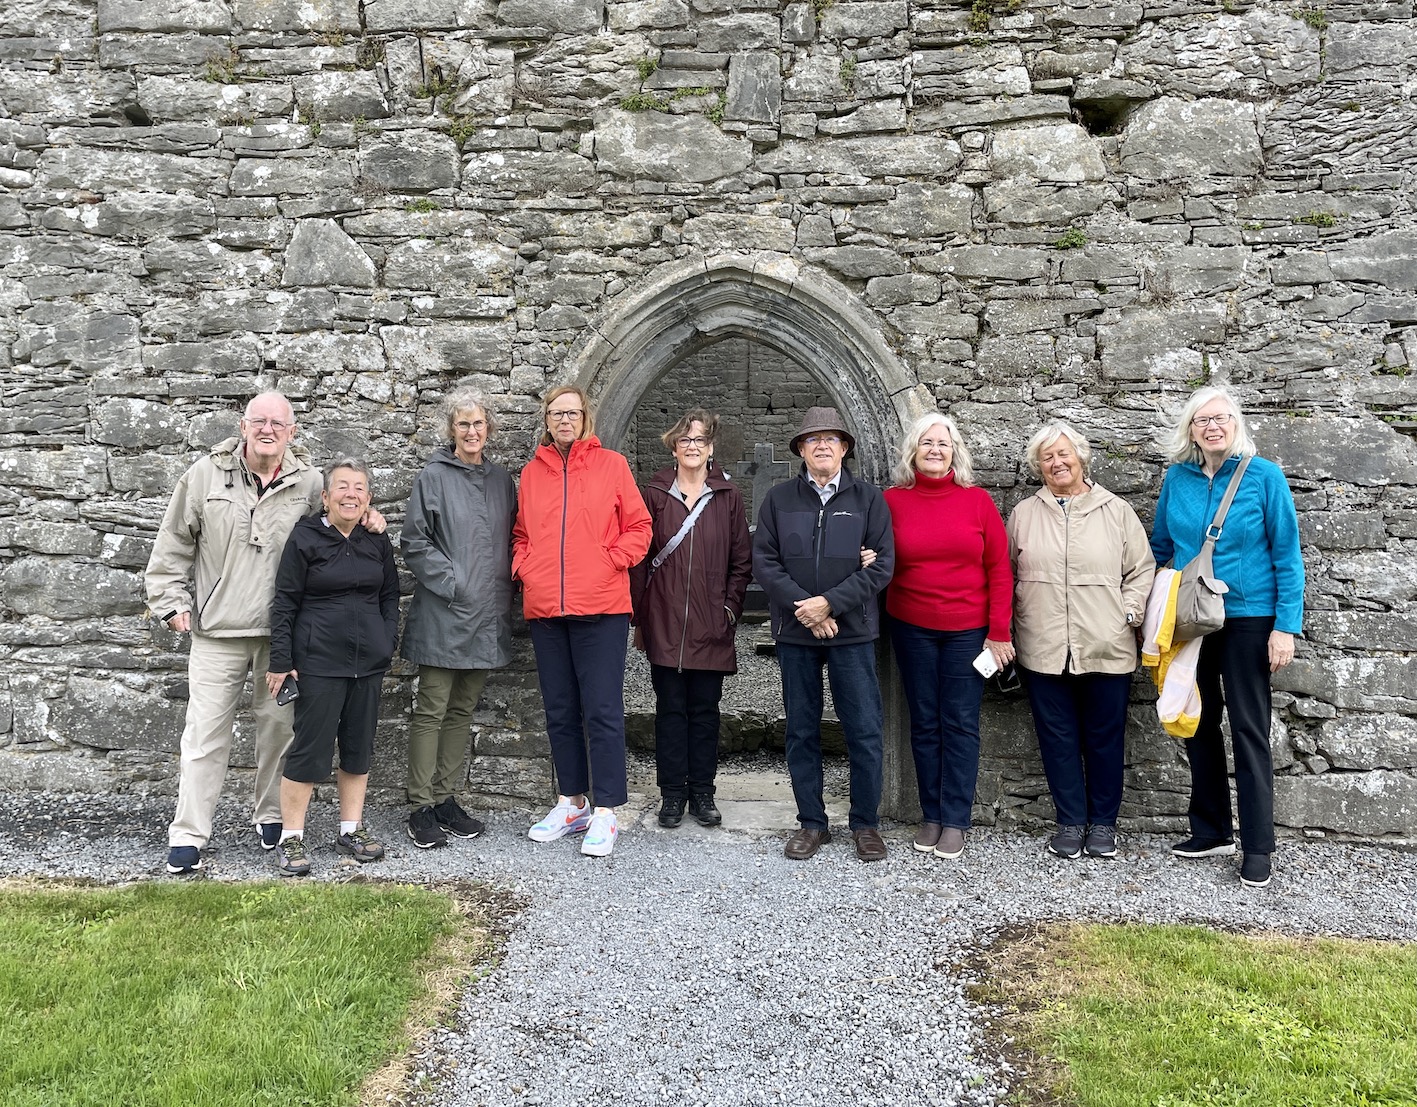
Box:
[752,465,896,646]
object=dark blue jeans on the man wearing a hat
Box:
[778,642,884,831]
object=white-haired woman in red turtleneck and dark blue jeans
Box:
[886,412,1013,859]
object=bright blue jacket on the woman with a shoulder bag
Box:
[1152,456,1304,634]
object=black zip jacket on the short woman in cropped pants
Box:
[271,516,398,678]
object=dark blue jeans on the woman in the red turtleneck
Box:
[890,619,988,831]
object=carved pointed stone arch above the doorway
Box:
[563,254,934,483]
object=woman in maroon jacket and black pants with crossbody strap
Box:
[631,408,752,826]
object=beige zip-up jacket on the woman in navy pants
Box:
[1007,483,1156,675]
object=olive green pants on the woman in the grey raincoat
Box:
[405,665,489,807]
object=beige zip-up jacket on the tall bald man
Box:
[143,438,323,638]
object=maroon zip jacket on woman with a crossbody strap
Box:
[629,465,752,673]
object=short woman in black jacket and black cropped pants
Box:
[266,458,398,876]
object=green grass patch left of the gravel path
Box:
[0,882,458,1107]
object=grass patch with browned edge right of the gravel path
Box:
[978,924,1417,1107]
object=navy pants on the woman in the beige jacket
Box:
[1023,669,1132,826]
